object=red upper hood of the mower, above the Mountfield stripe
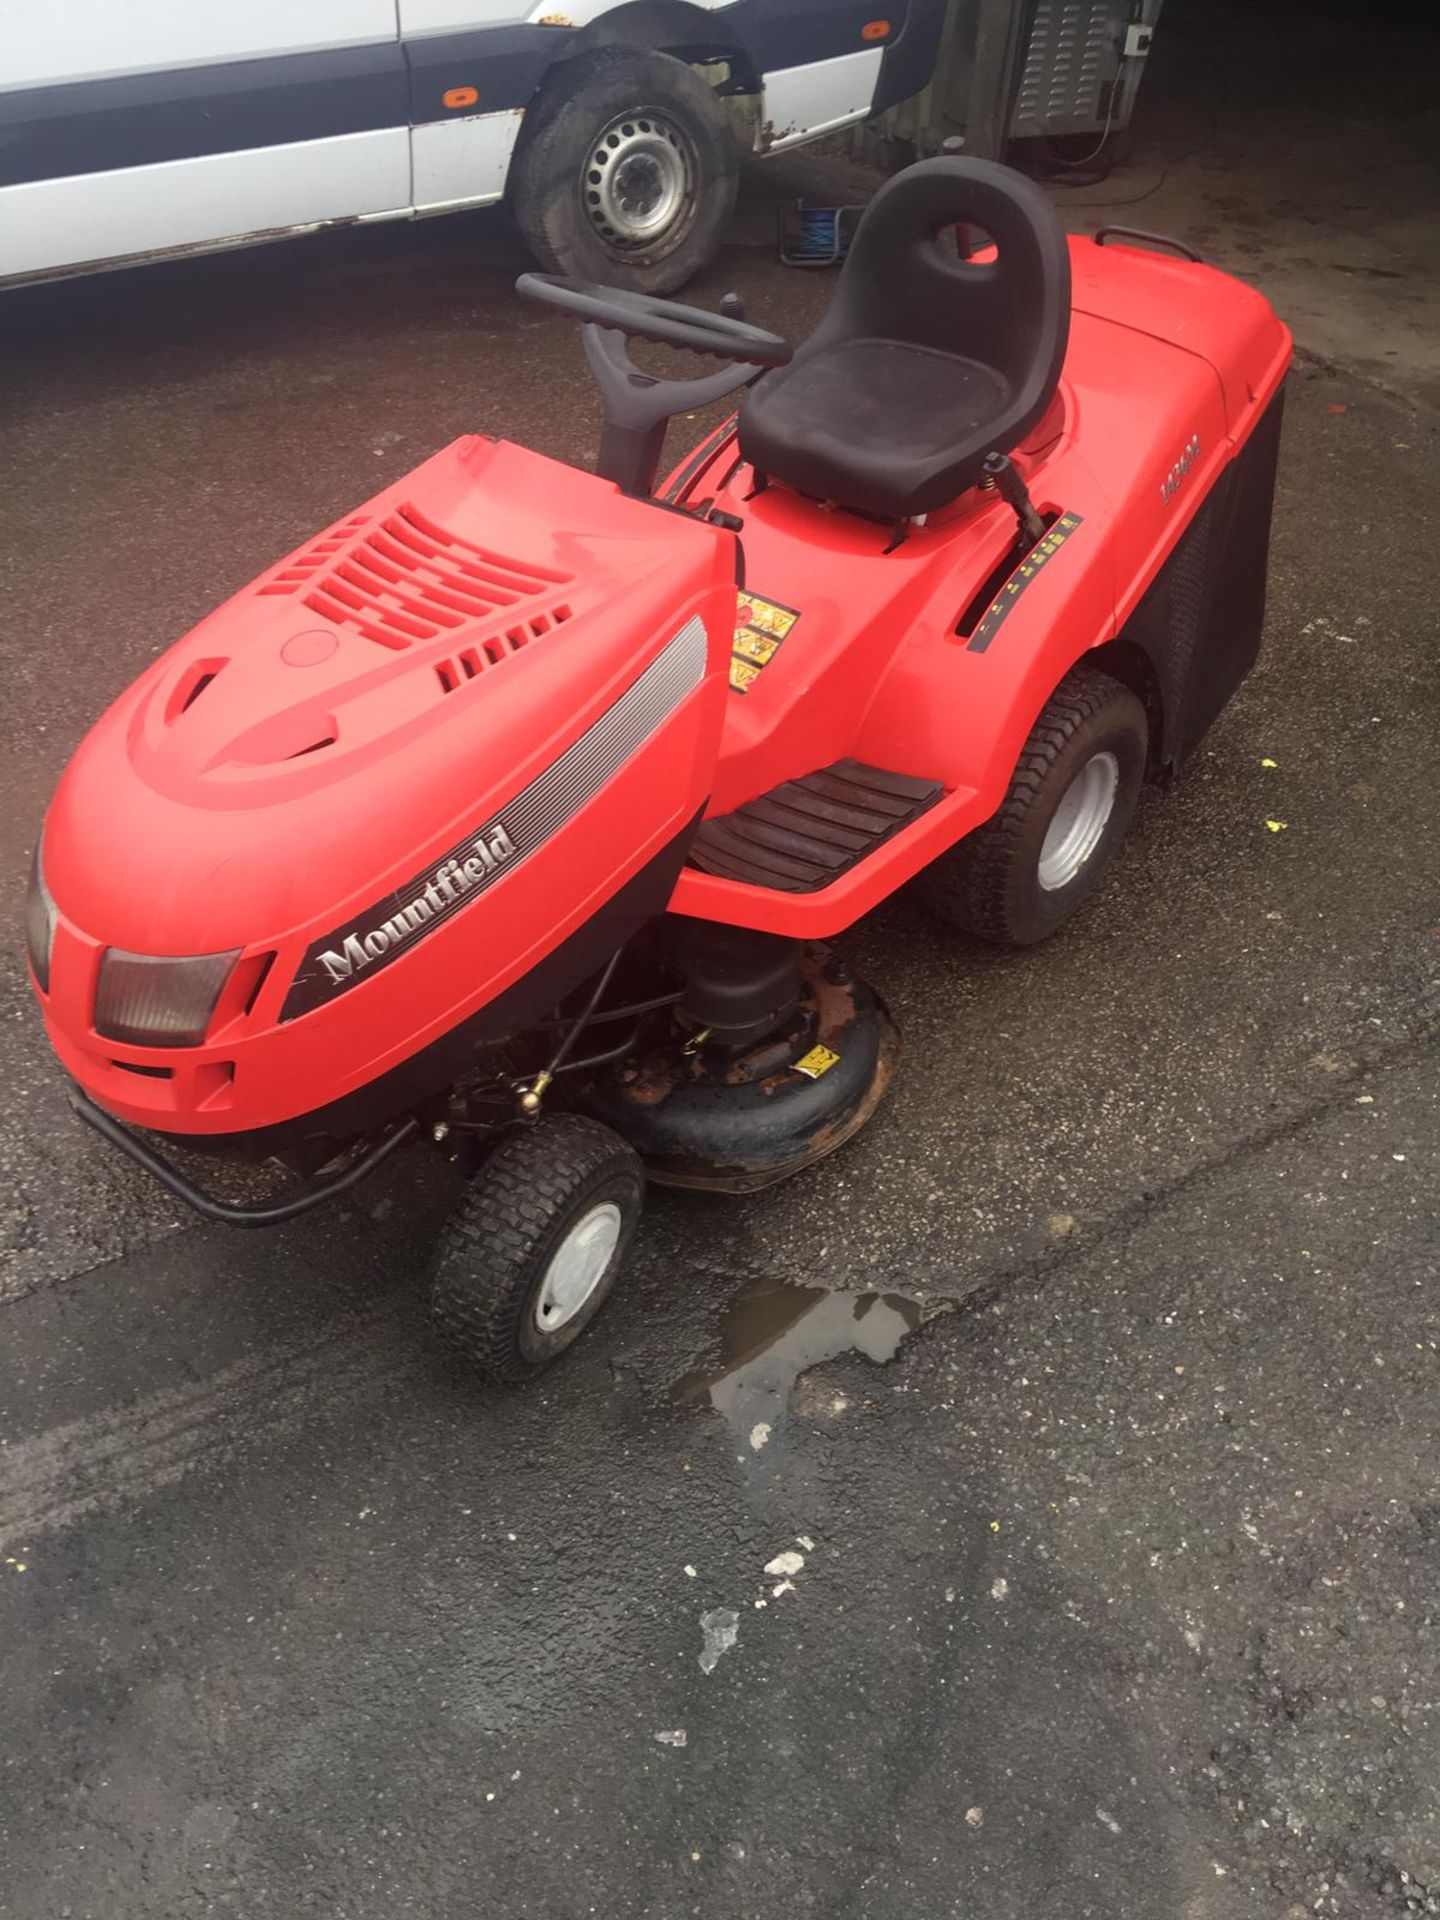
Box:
[44,438,730,954]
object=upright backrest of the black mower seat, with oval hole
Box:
[814,157,1069,405]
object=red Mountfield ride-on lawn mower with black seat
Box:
[29,159,1290,1380]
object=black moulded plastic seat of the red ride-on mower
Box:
[739,159,1069,520]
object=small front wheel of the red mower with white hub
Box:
[430,1114,645,1384]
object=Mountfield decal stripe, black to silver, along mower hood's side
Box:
[280,614,708,1021]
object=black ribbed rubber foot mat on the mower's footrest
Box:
[687,760,945,893]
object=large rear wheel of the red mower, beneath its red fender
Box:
[924,666,1148,947]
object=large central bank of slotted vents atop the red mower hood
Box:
[286,507,574,652]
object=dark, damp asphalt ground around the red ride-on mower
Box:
[0,153,1440,1920]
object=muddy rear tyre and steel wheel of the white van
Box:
[511,46,737,294]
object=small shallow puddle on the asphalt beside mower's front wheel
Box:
[672,1284,924,1452]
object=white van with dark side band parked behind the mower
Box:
[0,0,945,292]
